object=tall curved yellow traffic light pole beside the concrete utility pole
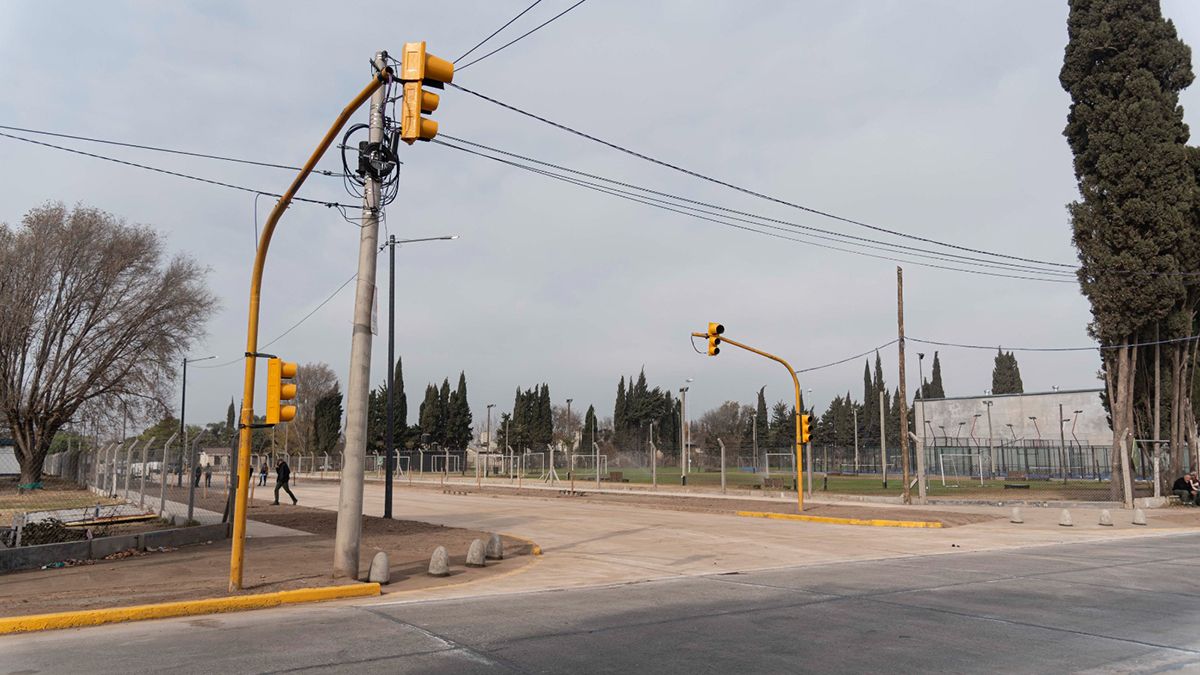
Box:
[229,68,392,592]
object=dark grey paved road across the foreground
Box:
[9,533,1200,674]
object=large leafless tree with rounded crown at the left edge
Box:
[0,203,216,485]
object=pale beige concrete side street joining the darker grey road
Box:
[283,483,1196,599]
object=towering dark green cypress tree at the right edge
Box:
[1058,0,1196,487]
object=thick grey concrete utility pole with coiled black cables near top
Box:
[334,52,386,579]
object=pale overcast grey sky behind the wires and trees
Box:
[0,0,1200,423]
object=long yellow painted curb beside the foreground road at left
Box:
[0,584,379,635]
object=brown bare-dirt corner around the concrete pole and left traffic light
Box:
[0,502,533,616]
